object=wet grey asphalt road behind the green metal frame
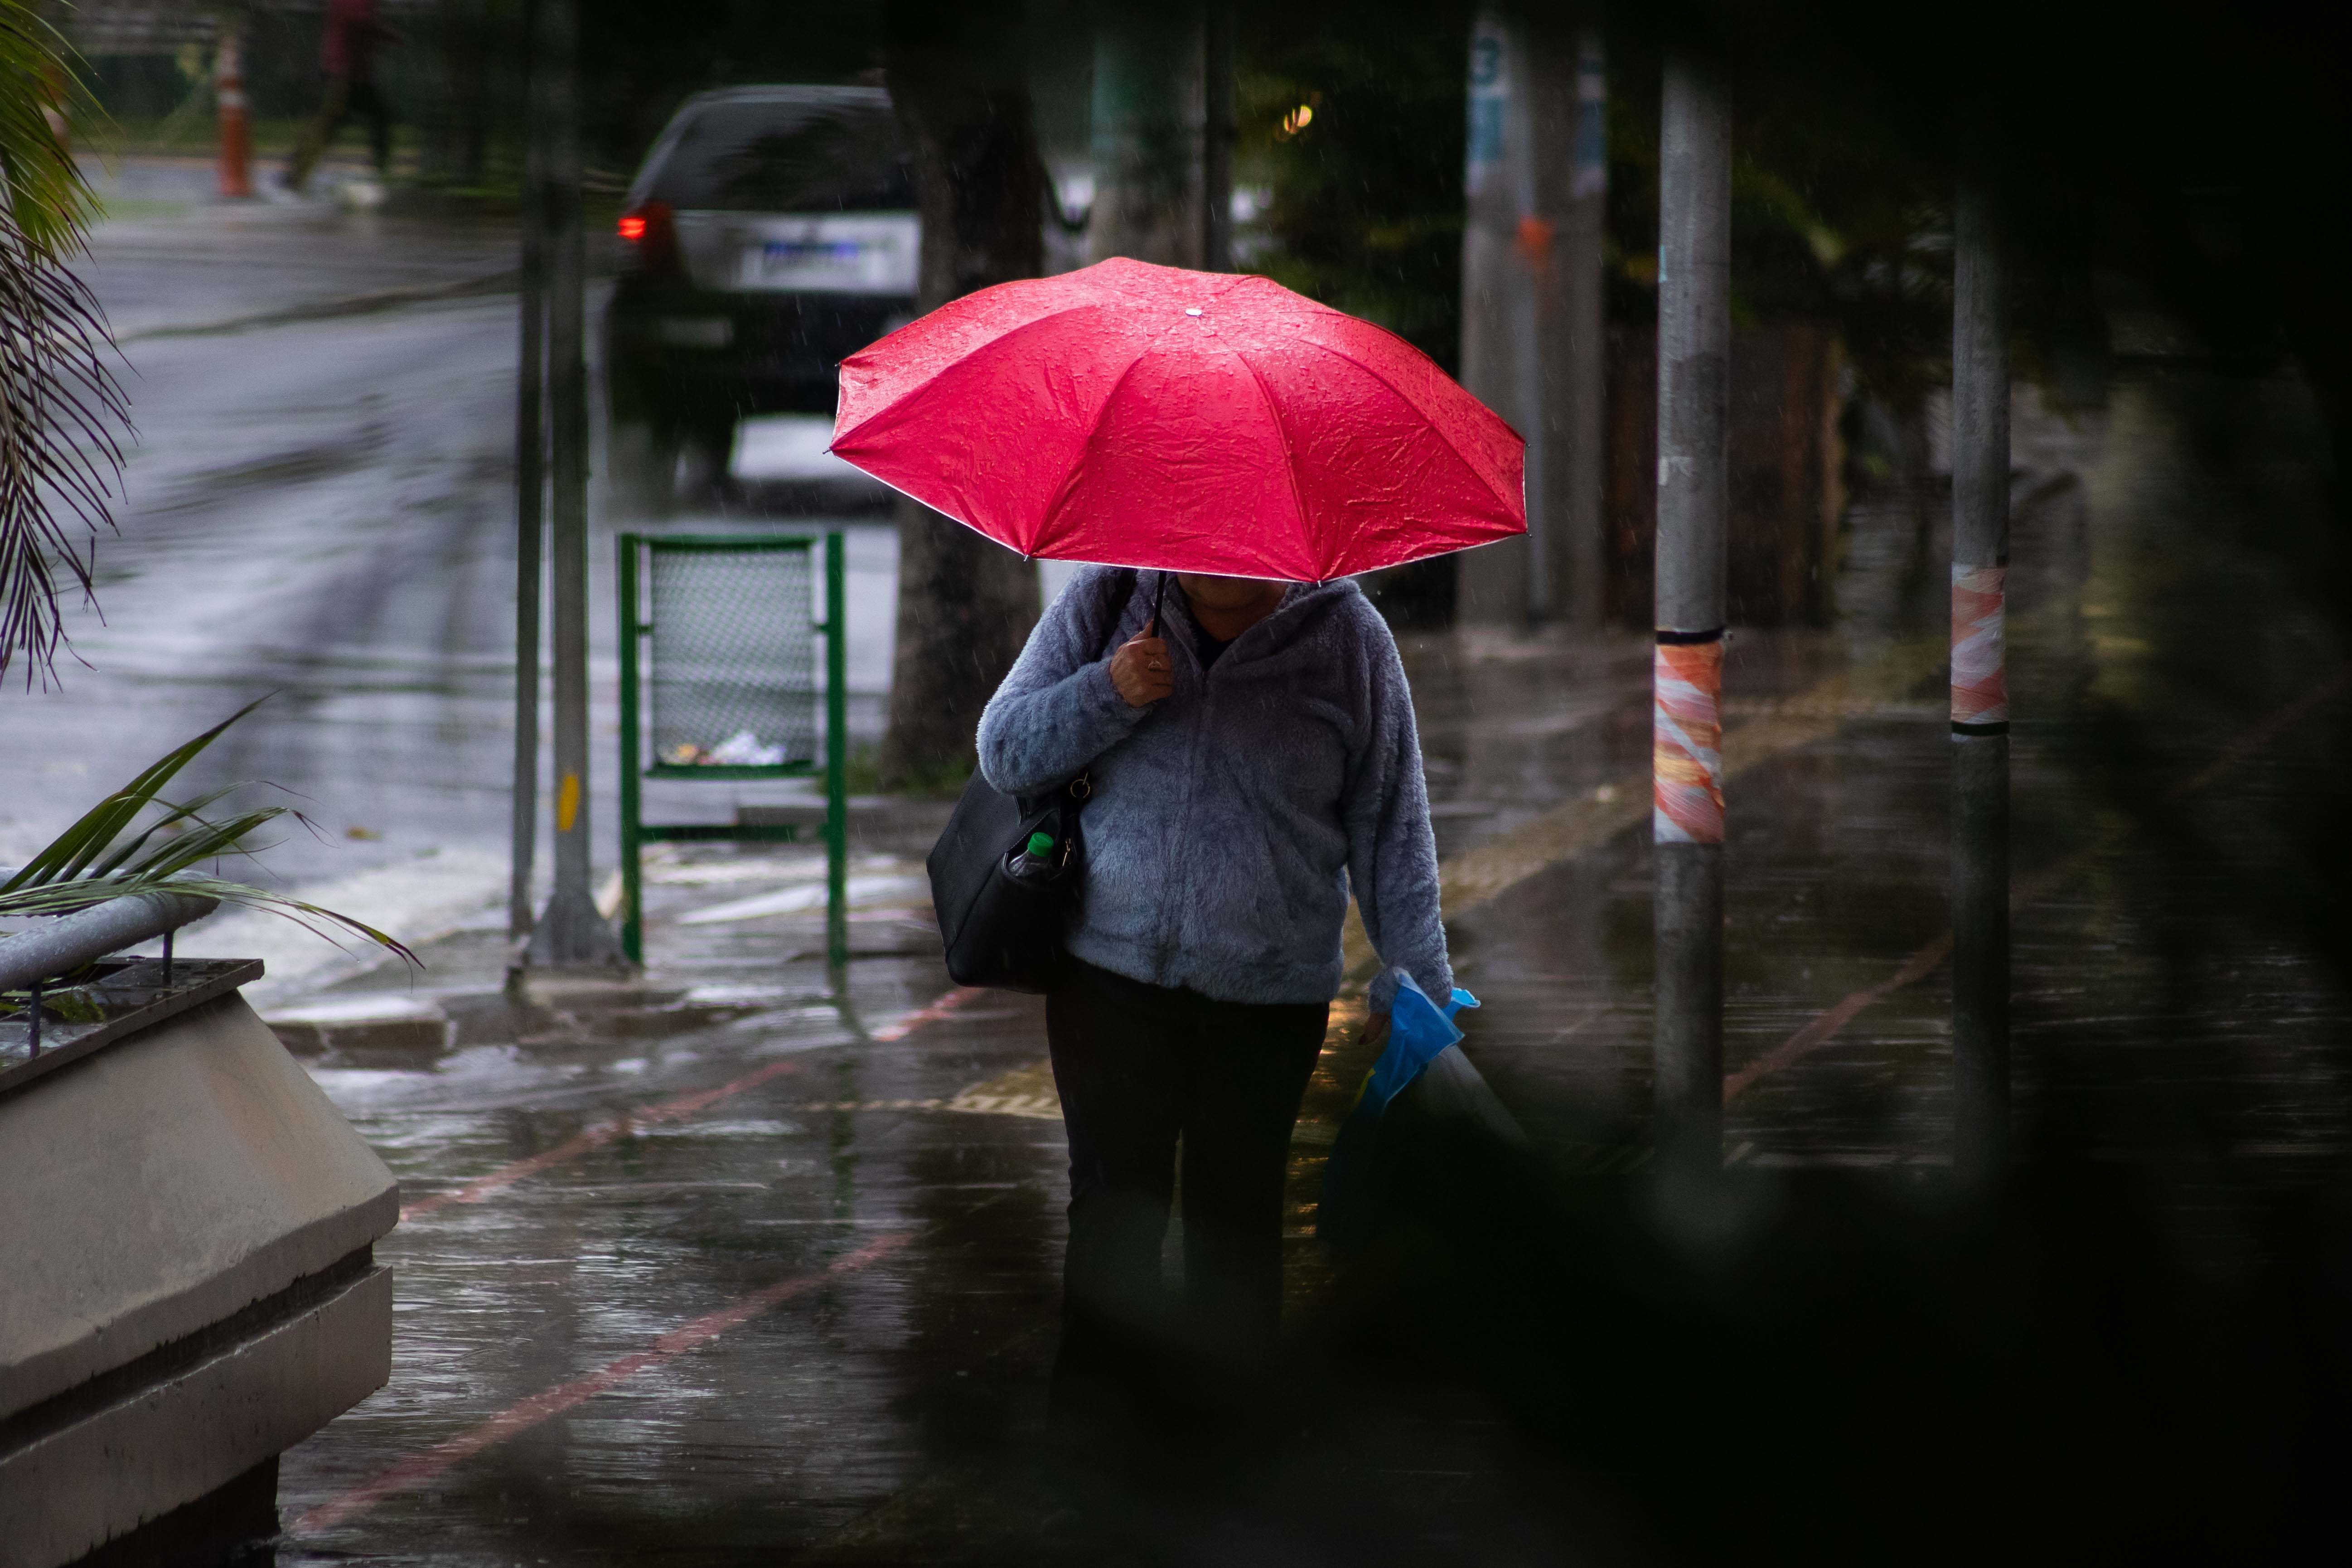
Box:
[0,160,896,992]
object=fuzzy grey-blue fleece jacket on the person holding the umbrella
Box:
[981,566,1453,1011]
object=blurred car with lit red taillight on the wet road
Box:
[605,87,920,501]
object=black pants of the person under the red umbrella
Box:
[1044,962,1331,1437]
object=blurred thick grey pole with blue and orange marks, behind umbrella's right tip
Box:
[1456,7,1609,630]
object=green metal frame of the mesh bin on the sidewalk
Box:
[616,529,849,964]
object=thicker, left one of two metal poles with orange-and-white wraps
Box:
[1651,56,1731,1176]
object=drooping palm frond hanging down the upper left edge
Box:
[0,0,129,687]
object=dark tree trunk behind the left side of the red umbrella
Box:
[880,0,1044,790]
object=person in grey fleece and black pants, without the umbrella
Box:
[978,566,1453,1457]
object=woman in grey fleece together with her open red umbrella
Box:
[832,261,1526,1437]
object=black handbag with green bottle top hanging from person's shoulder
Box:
[924,574,1136,992]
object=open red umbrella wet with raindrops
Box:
[832,259,1526,583]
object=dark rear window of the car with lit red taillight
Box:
[644,101,915,212]
